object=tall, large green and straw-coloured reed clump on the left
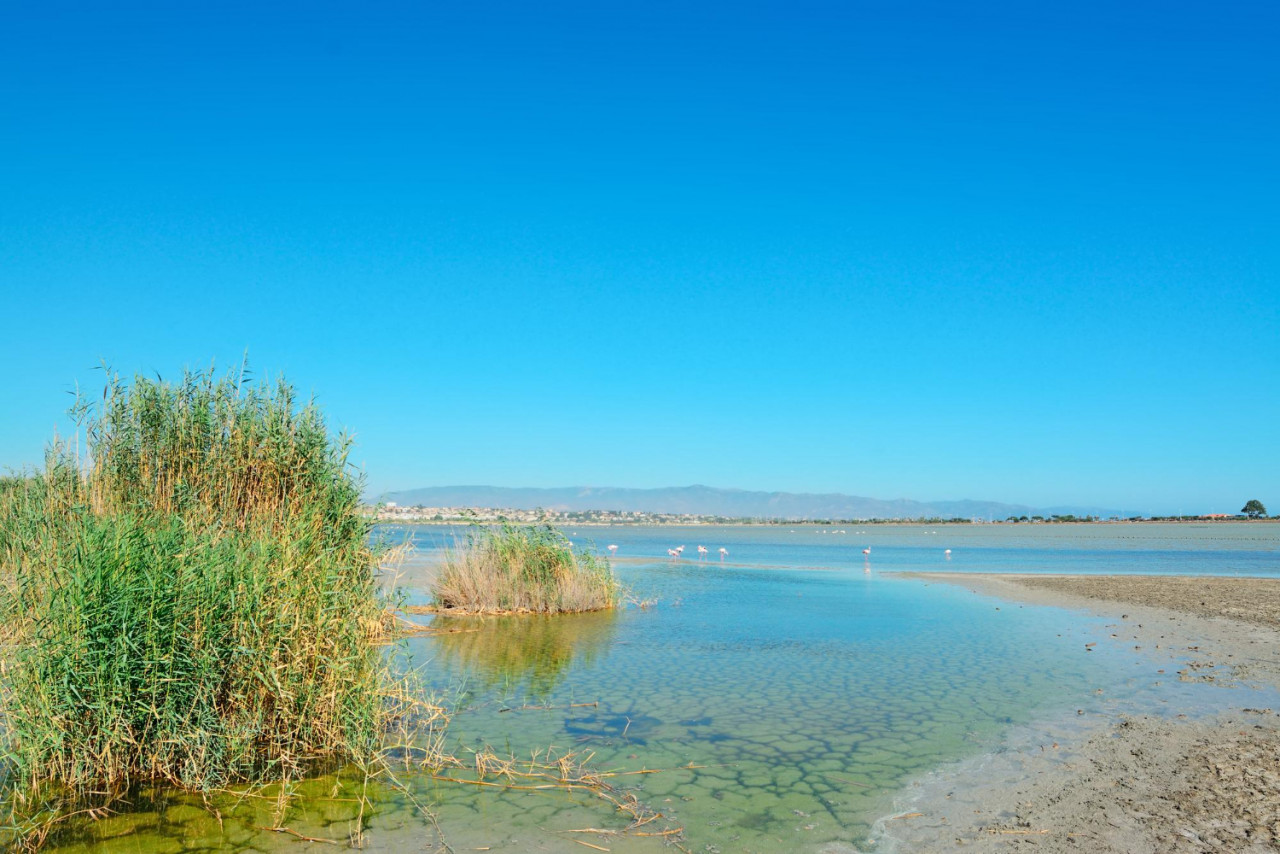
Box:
[0,370,404,839]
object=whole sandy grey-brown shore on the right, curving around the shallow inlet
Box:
[876,574,1280,854]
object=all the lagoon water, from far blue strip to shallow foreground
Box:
[42,524,1280,854]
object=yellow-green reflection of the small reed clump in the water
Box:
[431,611,618,697]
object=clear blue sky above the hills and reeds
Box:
[0,0,1280,512]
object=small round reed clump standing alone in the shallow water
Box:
[431,525,622,615]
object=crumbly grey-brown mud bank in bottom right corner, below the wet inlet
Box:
[877,709,1280,854]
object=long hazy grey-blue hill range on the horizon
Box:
[380,485,1134,519]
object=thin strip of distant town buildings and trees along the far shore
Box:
[369,502,1251,526]
